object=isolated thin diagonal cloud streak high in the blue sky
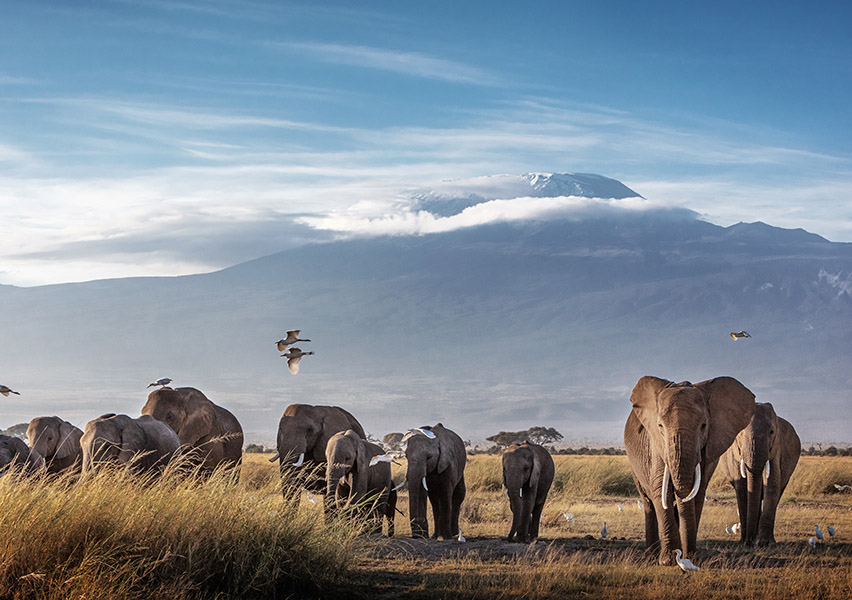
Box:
[270,42,499,85]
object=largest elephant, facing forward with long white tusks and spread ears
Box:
[624,376,755,565]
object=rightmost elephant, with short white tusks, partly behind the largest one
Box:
[719,402,802,546]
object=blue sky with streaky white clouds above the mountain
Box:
[0,0,852,285]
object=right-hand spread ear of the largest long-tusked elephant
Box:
[695,377,754,461]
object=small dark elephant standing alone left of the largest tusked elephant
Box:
[503,441,555,543]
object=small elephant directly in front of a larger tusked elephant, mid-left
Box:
[325,429,396,537]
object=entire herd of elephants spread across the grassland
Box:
[0,376,801,565]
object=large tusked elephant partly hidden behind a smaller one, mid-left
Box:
[269,404,367,491]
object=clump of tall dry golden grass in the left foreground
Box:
[0,454,361,600]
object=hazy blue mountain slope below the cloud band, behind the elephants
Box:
[0,188,852,443]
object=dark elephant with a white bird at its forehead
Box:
[402,423,467,540]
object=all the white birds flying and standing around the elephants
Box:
[0,329,852,572]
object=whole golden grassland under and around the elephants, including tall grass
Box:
[0,454,852,600]
